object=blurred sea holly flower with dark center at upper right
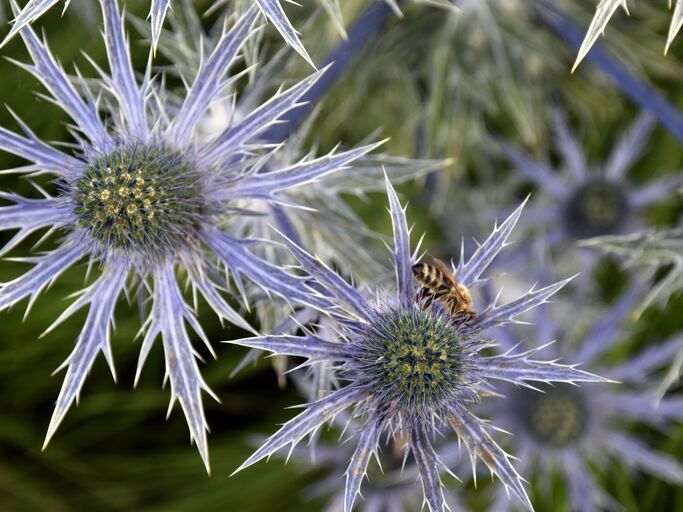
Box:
[500,111,683,248]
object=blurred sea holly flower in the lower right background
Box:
[489,290,683,512]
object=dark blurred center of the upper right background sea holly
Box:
[565,179,629,238]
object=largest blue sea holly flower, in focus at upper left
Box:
[0,0,382,469]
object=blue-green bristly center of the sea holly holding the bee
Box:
[360,308,464,408]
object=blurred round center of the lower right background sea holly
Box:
[515,384,588,447]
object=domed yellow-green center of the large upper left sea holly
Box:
[73,145,202,256]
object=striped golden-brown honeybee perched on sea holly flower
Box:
[413,257,477,323]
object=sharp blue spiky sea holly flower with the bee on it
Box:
[233,180,602,511]
